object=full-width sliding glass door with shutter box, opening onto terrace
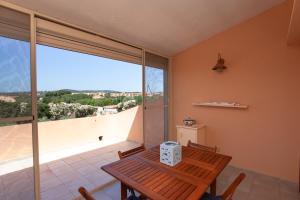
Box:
[0,4,168,200]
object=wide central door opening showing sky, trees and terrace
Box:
[37,45,143,199]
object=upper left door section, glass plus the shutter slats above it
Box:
[0,6,31,118]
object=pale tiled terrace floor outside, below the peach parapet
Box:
[0,141,138,200]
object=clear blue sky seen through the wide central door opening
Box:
[37,45,142,92]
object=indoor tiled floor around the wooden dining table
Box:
[89,166,300,200]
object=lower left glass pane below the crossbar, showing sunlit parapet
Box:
[0,122,34,200]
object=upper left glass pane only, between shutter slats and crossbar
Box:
[0,36,31,118]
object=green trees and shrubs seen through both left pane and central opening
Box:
[0,90,142,122]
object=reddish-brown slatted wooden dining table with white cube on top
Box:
[101,146,231,200]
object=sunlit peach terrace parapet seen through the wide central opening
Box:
[38,106,143,154]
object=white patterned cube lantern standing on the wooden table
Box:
[160,141,182,166]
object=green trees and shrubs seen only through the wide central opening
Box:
[38,90,142,120]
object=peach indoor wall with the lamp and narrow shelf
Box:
[171,1,300,181]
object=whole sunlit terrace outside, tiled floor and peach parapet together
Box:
[0,106,143,200]
